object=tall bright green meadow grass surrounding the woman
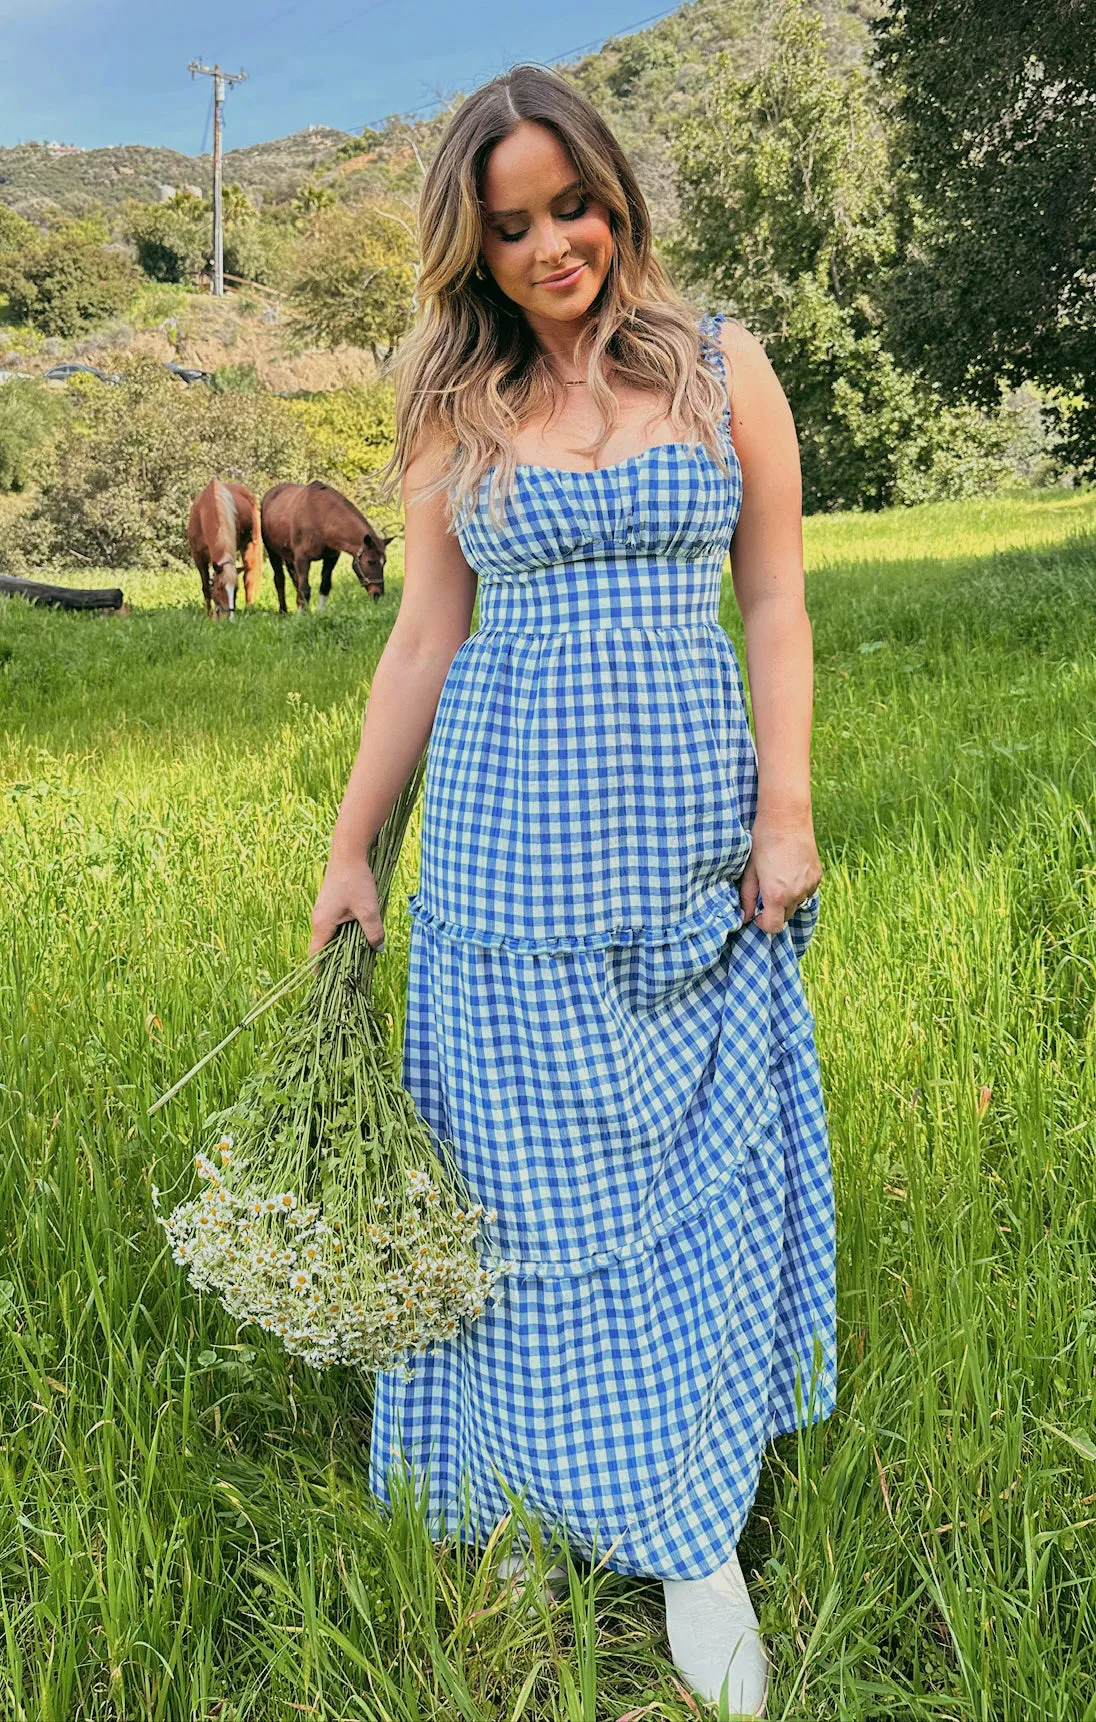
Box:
[0,491,1096,1722]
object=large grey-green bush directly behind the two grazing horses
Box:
[9,353,324,568]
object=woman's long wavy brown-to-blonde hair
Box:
[379,64,727,525]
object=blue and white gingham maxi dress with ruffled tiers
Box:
[371,313,836,1579]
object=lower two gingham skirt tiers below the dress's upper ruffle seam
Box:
[363,878,836,1579]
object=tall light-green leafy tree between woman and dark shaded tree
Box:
[672,0,1006,510]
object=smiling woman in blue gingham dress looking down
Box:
[312,65,836,1713]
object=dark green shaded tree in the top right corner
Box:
[874,0,1096,468]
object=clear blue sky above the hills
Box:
[0,0,670,155]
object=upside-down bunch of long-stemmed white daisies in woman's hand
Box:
[150,756,514,1378]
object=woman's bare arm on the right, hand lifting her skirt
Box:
[722,320,822,933]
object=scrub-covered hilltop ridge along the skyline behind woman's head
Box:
[0,0,881,232]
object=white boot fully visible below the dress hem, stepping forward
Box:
[662,1552,769,1717]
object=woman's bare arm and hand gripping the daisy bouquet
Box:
[310,449,476,952]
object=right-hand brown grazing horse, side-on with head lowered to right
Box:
[262,479,391,613]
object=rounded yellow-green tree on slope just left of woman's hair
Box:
[290,205,419,358]
